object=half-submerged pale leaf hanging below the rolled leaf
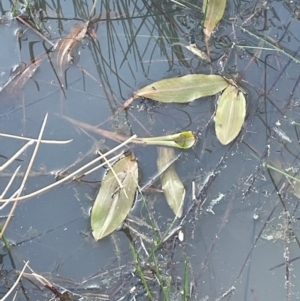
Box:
[157,147,185,218]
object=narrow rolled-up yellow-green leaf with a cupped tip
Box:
[138,131,197,149]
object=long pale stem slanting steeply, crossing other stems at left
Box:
[0,113,48,238]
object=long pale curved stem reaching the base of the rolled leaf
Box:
[0,135,136,202]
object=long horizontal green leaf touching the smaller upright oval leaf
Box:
[133,74,229,103]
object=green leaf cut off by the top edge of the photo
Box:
[202,0,226,39]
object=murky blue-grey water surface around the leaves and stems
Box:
[0,0,300,300]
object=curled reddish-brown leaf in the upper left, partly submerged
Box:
[52,22,89,82]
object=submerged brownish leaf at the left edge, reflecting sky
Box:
[0,59,42,110]
